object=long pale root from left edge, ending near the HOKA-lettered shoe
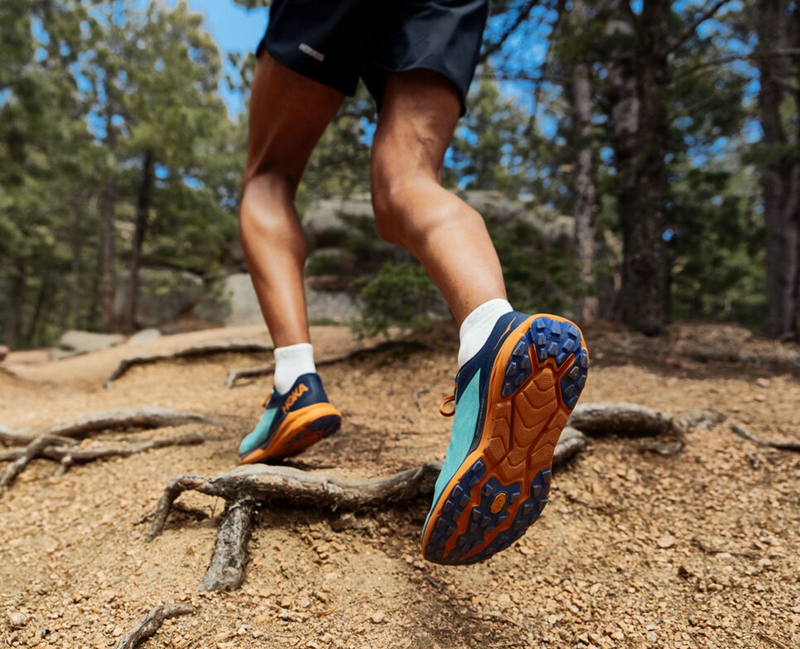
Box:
[0,408,225,446]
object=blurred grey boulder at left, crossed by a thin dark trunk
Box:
[114,268,203,327]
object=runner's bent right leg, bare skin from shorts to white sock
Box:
[372,70,506,325]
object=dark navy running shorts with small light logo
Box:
[256,0,490,114]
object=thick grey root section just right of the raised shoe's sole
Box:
[569,402,678,437]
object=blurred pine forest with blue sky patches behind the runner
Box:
[0,0,800,349]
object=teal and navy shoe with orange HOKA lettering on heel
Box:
[239,374,342,464]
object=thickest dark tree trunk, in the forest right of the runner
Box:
[609,0,670,335]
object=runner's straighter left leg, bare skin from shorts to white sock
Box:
[240,52,344,347]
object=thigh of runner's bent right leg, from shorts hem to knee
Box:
[372,70,461,182]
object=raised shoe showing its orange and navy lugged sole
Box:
[422,312,589,564]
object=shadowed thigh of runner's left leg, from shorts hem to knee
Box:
[243,52,344,192]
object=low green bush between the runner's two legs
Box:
[353,263,441,337]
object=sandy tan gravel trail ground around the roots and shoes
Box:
[0,326,800,649]
